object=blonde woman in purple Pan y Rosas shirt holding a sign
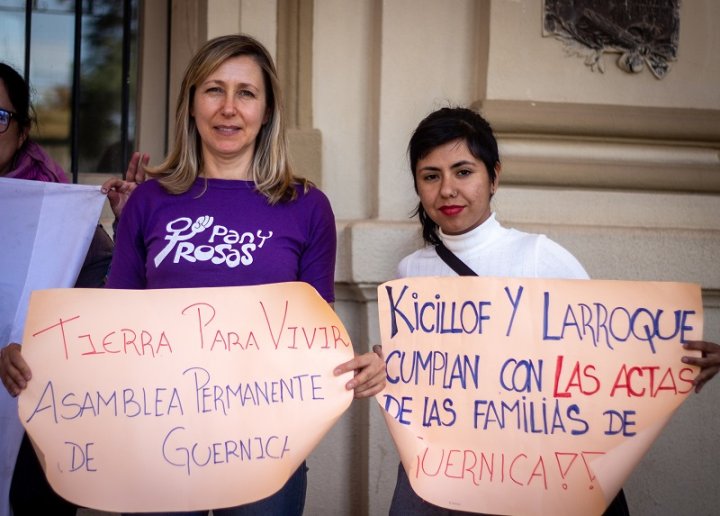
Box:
[108,35,385,515]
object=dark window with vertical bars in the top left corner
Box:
[0,0,138,181]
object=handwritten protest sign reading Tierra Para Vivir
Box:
[19,283,353,512]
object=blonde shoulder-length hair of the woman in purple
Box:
[148,34,310,204]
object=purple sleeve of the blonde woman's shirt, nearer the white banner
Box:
[105,185,147,289]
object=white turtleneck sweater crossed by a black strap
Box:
[398,213,588,279]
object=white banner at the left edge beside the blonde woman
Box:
[0,178,105,516]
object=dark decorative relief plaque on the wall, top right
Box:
[543,0,680,79]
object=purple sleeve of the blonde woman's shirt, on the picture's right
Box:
[299,189,337,303]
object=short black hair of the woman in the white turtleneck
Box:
[408,107,500,245]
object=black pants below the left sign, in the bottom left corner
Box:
[10,434,78,516]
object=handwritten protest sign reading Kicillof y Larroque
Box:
[377,277,703,515]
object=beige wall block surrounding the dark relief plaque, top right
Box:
[487,0,720,109]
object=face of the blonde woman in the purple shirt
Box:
[191,56,267,175]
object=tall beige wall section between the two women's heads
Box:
[313,0,484,220]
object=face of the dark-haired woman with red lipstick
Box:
[415,140,500,235]
